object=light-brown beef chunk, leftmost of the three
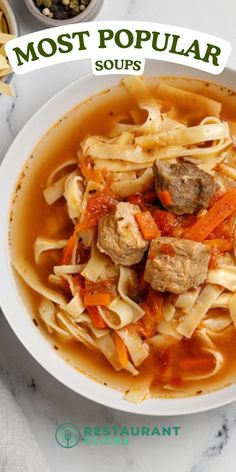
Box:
[97,202,148,266]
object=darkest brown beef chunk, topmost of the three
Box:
[153,159,218,215]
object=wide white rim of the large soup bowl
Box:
[0,61,236,416]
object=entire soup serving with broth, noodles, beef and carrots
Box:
[2,66,236,414]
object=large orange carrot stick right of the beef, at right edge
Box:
[184,189,236,242]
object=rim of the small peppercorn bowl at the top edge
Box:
[24,0,104,27]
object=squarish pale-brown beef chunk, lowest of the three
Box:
[144,237,210,294]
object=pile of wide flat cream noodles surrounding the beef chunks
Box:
[13,77,236,402]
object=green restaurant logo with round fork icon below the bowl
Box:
[55,423,180,449]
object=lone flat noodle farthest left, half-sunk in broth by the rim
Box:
[12,257,65,305]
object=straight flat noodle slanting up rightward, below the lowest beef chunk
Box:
[177,284,223,338]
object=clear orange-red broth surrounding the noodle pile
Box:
[10,78,236,397]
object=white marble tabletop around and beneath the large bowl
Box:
[0,0,236,472]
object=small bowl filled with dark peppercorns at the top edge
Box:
[25,0,103,26]
